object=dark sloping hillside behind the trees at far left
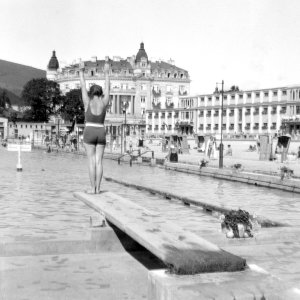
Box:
[0,59,46,104]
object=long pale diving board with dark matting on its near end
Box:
[74,192,246,274]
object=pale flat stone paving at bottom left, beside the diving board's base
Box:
[0,252,148,300]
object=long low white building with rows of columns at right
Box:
[146,85,300,136]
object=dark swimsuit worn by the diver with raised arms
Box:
[83,103,106,146]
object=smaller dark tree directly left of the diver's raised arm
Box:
[59,89,84,123]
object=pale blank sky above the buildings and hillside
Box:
[0,0,300,94]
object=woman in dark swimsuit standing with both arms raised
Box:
[79,57,110,194]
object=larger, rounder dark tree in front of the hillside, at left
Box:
[22,78,63,122]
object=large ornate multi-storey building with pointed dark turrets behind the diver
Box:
[47,43,190,135]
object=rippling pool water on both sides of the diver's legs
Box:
[0,148,300,242]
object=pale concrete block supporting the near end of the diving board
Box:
[148,270,300,300]
